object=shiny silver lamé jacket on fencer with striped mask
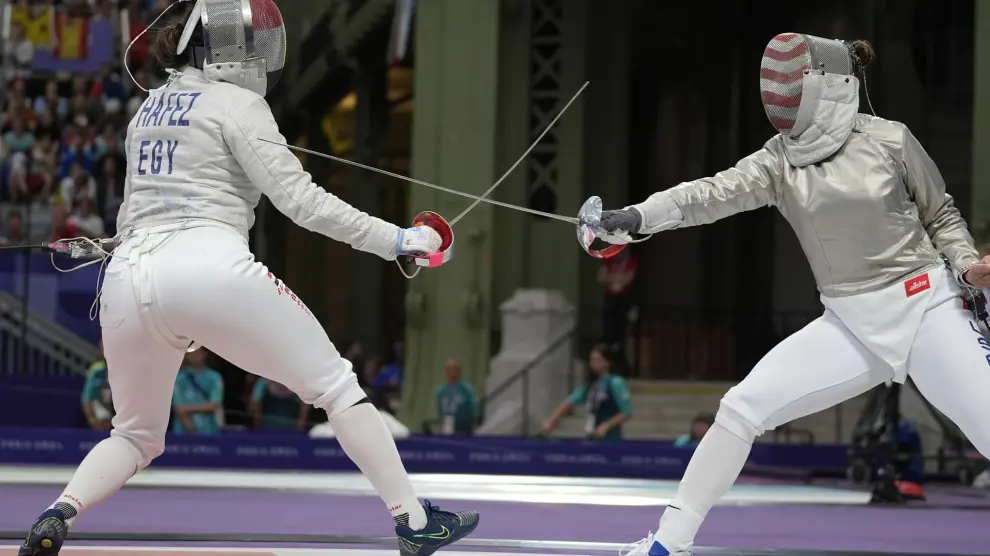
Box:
[634,112,978,297]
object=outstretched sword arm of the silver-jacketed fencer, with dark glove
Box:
[602,143,785,234]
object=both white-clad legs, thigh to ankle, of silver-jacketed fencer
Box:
[655,278,990,554]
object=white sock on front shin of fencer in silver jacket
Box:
[653,423,753,554]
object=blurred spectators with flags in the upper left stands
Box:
[0,0,168,244]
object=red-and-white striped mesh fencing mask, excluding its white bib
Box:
[760,33,859,136]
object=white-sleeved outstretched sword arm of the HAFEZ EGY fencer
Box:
[223,97,400,260]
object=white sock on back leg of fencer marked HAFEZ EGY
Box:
[49,436,141,526]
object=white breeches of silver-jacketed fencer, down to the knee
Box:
[717,292,990,456]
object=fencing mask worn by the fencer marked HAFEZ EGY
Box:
[178,0,286,96]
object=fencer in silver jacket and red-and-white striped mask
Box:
[601,33,990,556]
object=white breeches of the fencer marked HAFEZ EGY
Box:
[100,225,364,468]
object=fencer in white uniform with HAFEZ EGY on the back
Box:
[14,0,478,556]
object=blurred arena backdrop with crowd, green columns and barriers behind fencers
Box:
[0,0,990,540]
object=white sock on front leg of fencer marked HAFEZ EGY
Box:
[330,403,426,530]
